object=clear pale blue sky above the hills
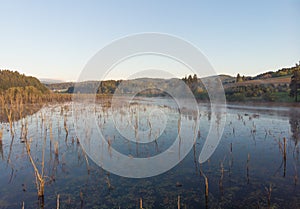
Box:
[0,0,300,81]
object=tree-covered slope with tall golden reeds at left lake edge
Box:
[0,70,72,123]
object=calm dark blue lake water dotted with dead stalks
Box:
[0,98,300,209]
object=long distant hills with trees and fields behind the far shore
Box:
[40,63,300,101]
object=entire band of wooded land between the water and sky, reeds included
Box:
[0,63,300,103]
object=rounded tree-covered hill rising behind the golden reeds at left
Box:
[0,70,49,93]
